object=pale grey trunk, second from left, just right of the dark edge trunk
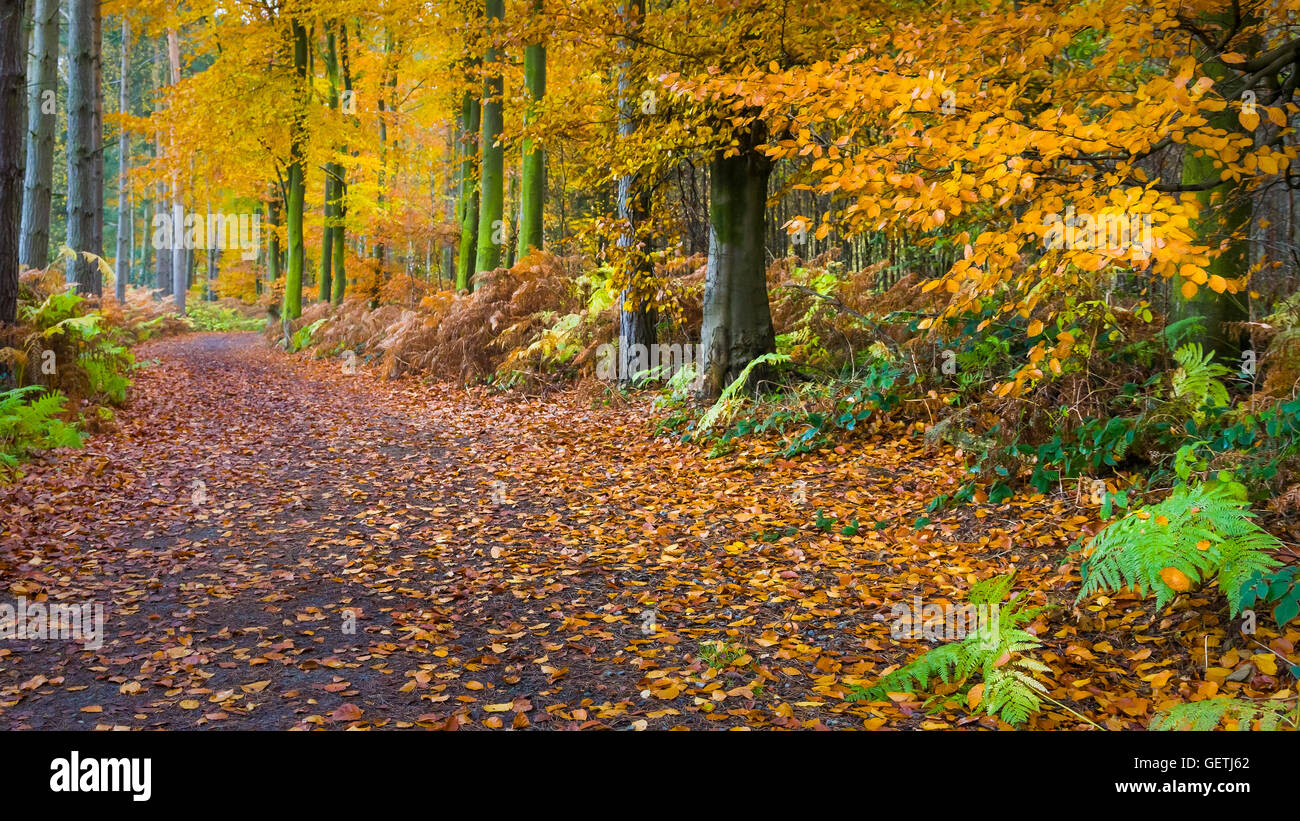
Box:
[18,0,59,268]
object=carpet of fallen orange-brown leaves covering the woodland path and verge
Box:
[0,334,1300,730]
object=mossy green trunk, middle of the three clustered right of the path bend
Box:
[475,0,506,272]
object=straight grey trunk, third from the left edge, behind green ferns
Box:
[68,0,103,296]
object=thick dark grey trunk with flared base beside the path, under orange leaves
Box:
[701,125,776,396]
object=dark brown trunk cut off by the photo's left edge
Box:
[0,3,27,326]
